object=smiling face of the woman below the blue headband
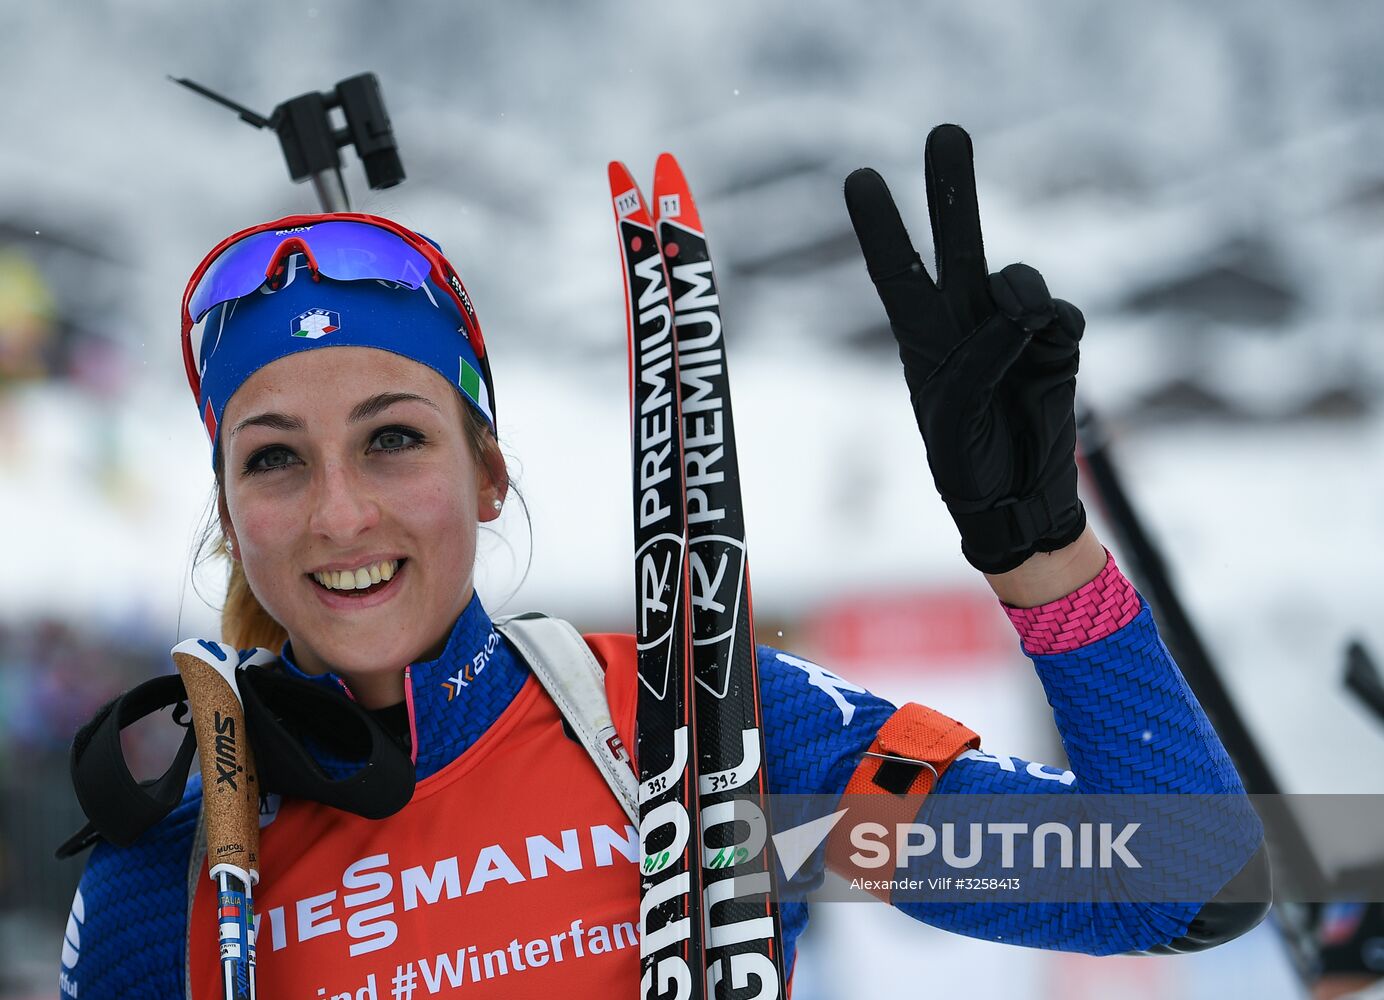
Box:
[213,347,507,708]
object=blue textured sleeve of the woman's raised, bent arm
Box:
[760,604,1262,954]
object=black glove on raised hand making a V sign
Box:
[846,124,1086,573]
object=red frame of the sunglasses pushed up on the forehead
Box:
[183,212,490,401]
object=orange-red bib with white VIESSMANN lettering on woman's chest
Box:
[190,636,639,1000]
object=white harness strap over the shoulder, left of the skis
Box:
[495,611,639,826]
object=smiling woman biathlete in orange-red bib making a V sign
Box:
[62,126,1266,1000]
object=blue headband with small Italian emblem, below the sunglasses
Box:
[198,253,495,466]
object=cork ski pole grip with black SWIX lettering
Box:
[173,643,259,882]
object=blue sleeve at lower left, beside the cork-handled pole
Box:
[60,773,202,1000]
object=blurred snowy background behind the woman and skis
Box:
[0,0,1384,1000]
